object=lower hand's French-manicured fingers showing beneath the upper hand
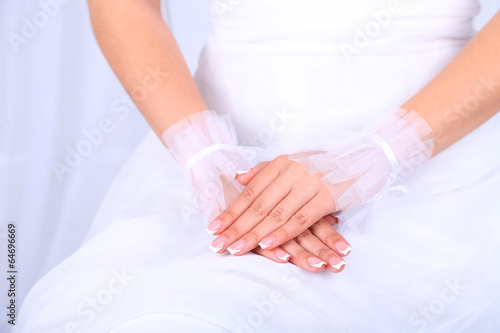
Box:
[253,216,351,273]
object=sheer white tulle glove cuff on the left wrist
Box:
[162,111,257,227]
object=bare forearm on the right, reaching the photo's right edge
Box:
[402,13,500,155]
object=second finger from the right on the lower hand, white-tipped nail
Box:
[295,229,345,273]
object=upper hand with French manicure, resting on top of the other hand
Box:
[208,155,342,255]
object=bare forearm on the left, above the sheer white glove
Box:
[88,0,207,137]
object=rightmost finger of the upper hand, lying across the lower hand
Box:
[260,192,331,250]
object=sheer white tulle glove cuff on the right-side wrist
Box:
[291,109,433,229]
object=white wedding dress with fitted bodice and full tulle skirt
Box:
[14,0,500,333]
